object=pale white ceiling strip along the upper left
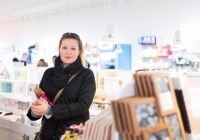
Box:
[0,0,123,20]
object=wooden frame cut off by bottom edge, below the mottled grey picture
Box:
[142,124,173,140]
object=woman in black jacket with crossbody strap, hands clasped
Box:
[27,33,96,140]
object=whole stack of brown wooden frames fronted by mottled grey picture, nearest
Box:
[111,97,162,136]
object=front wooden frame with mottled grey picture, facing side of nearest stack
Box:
[128,97,163,136]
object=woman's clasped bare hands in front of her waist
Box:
[31,99,48,116]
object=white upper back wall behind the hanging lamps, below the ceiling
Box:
[0,0,200,69]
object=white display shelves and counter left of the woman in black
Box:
[0,63,43,140]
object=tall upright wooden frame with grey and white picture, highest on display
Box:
[150,72,178,116]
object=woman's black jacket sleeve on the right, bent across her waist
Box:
[51,70,96,120]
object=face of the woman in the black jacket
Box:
[59,38,80,65]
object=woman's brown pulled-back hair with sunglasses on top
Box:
[58,32,85,66]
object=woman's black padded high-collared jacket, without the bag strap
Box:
[27,57,96,140]
